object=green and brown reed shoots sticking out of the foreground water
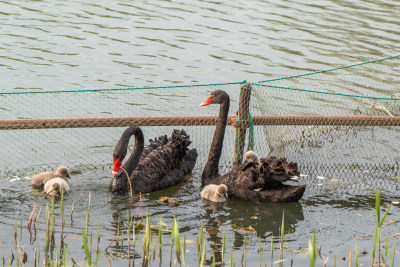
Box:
[0,189,399,266]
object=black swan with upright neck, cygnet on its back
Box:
[201,90,305,202]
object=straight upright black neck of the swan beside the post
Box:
[201,94,230,185]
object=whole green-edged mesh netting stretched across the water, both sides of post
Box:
[0,57,400,195]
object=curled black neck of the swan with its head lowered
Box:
[115,126,144,175]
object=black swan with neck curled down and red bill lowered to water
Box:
[109,126,197,193]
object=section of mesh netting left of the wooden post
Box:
[0,84,240,175]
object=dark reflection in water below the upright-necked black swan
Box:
[202,198,304,264]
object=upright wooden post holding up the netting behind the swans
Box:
[233,83,251,166]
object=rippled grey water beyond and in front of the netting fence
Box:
[0,0,400,266]
